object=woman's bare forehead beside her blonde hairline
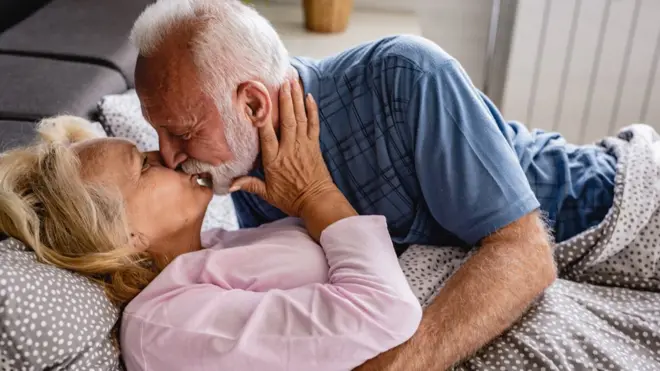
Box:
[73,138,141,183]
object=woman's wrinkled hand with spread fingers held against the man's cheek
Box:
[231,81,338,217]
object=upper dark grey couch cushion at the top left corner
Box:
[0,0,152,86]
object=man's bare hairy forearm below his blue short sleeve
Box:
[356,212,556,371]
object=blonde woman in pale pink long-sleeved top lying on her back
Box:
[0,84,421,371]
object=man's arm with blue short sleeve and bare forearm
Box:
[360,38,556,371]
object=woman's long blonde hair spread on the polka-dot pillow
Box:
[0,116,156,307]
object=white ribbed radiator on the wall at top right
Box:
[500,0,660,143]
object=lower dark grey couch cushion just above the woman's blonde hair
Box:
[0,55,127,121]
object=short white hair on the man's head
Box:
[131,0,290,108]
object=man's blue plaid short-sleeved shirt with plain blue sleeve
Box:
[232,36,614,245]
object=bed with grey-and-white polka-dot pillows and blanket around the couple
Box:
[0,91,660,371]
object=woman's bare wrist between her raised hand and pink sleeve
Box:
[300,187,358,241]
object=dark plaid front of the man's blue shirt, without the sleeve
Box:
[234,50,441,247]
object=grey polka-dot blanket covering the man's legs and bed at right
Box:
[400,125,660,371]
